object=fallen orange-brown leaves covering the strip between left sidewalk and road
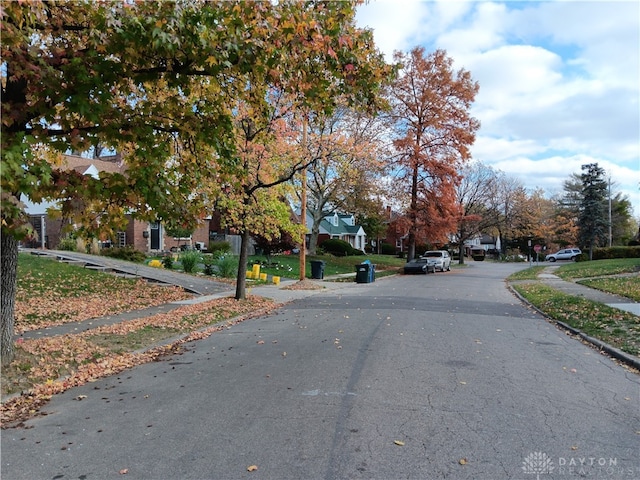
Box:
[0,296,277,428]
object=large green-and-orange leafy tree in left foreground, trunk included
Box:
[0,0,388,362]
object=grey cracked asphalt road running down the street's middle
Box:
[1,263,640,480]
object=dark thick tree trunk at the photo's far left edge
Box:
[0,229,18,365]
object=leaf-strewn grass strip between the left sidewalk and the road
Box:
[0,297,277,428]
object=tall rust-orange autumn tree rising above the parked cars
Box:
[390,47,480,259]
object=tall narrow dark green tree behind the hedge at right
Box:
[578,163,609,260]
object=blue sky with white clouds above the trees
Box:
[356,0,640,216]
